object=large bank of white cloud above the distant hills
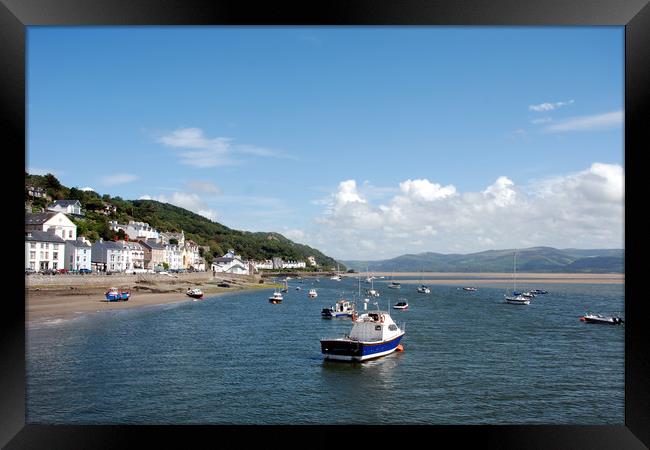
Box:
[302,163,625,259]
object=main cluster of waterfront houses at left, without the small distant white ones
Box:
[25,212,206,272]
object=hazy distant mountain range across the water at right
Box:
[342,247,625,273]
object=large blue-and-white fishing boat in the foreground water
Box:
[320,310,406,362]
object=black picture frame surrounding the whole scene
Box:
[0,0,650,449]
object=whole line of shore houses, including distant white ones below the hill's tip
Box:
[25,200,317,275]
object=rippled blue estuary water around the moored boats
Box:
[26,278,625,425]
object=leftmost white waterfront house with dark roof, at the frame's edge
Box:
[25,230,65,270]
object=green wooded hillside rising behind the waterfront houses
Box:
[25,173,345,270]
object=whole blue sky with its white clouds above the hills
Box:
[26,27,624,259]
